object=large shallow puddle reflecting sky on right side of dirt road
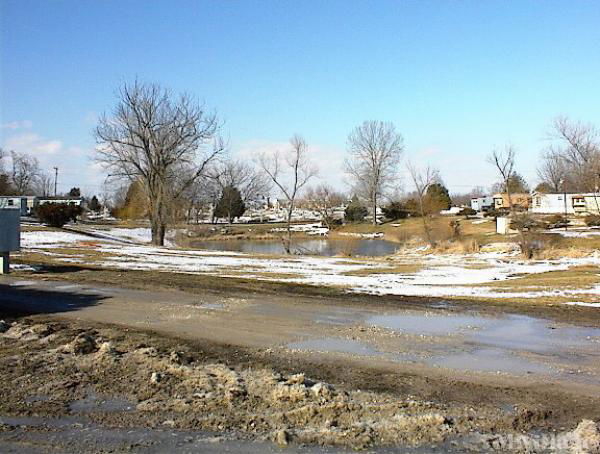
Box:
[356,311,600,376]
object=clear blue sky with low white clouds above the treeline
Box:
[0,0,600,195]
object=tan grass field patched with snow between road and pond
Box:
[10,218,600,307]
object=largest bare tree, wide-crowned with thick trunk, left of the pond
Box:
[95,81,224,246]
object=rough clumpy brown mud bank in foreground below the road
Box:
[0,316,596,452]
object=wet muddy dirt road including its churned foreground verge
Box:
[0,277,600,452]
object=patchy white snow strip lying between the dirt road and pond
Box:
[17,229,600,304]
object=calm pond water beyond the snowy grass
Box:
[192,238,398,257]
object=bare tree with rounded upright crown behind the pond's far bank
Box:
[345,121,404,225]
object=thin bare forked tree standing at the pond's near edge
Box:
[258,135,317,254]
